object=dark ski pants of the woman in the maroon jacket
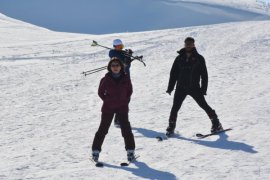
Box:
[92,113,135,151]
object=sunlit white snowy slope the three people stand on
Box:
[0,15,270,180]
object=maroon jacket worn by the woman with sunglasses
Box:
[98,73,132,113]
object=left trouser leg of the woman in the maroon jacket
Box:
[92,113,114,151]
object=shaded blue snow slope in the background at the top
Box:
[0,0,270,34]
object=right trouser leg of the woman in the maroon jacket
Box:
[118,113,135,150]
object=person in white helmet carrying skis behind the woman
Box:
[109,39,133,127]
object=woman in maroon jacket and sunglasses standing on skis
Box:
[92,58,135,162]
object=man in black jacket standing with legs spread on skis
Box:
[166,37,223,136]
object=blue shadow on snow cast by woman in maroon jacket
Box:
[105,161,176,180]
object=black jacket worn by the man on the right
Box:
[167,48,208,95]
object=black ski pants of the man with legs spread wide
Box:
[169,89,217,123]
